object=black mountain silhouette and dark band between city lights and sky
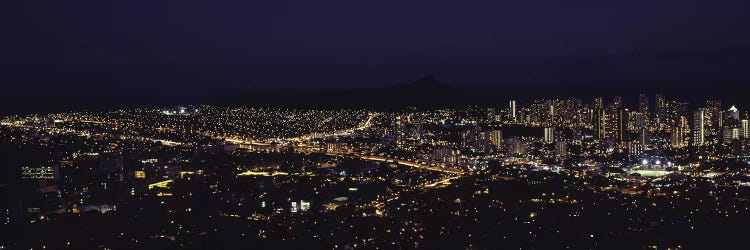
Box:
[0,75,750,115]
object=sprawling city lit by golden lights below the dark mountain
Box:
[0,92,750,248]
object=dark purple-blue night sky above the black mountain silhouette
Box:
[5,0,750,99]
